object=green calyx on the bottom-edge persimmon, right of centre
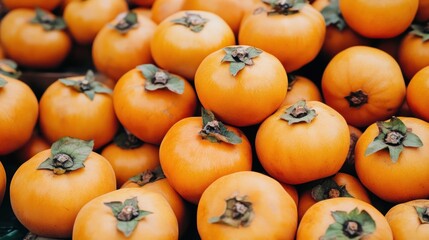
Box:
[320,208,376,240]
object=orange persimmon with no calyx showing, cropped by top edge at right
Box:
[339,0,419,38]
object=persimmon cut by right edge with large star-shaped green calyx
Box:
[355,117,429,203]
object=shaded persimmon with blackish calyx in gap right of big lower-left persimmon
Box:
[100,130,159,187]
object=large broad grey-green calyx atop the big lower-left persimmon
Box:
[37,137,94,174]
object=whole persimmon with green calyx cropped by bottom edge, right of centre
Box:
[296,198,393,240]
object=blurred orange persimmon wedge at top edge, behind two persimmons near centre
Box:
[182,0,260,34]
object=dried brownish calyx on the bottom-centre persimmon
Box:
[209,196,254,228]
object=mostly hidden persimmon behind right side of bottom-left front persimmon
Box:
[121,166,190,236]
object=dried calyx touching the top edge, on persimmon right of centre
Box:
[253,0,306,16]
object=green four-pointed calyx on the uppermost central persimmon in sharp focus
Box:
[221,46,262,77]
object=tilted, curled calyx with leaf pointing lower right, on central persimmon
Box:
[199,108,242,144]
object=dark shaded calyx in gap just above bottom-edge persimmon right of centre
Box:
[311,178,353,202]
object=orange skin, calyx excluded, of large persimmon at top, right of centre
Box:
[238,4,326,72]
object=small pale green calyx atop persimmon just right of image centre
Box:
[280,100,317,125]
